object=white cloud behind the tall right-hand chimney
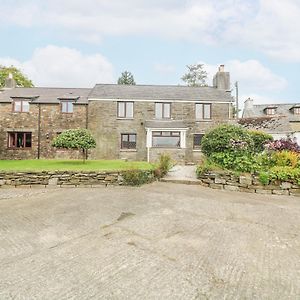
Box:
[204,59,288,93]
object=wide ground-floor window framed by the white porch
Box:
[152,131,180,148]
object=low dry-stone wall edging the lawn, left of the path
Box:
[0,170,153,187]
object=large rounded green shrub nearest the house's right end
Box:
[201,125,254,157]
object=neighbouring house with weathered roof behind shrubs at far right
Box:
[239,98,300,143]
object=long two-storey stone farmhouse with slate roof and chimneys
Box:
[0,65,234,162]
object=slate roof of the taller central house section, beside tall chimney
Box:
[89,84,233,102]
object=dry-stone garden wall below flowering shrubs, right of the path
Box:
[198,172,300,197]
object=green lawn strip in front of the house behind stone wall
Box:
[0,159,153,171]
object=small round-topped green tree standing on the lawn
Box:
[52,129,96,162]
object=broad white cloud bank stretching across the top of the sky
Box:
[0,0,300,62]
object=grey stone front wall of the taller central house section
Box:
[88,100,232,162]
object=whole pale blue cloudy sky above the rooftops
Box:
[0,0,300,104]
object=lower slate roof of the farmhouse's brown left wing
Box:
[0,87,91,104]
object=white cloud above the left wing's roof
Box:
[0,45,113,87]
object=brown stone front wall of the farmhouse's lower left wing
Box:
[0,103,87,159]
